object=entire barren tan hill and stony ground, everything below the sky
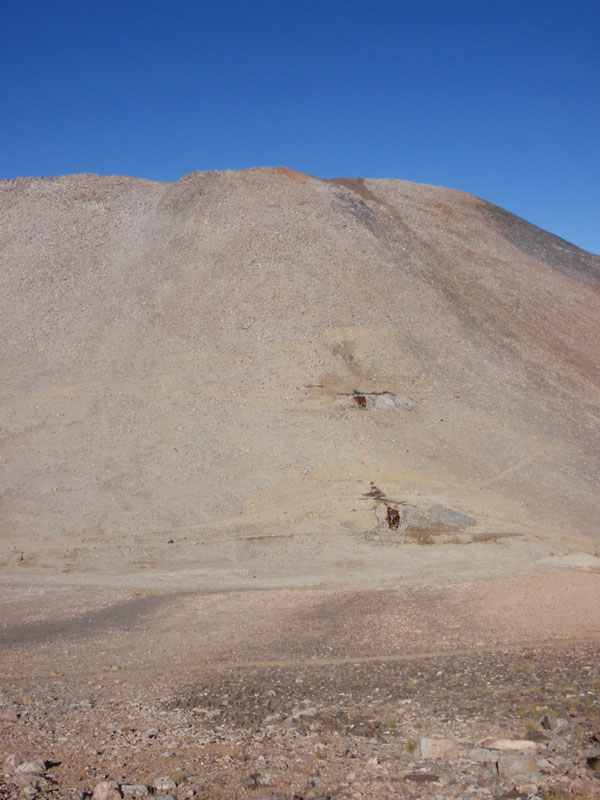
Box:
[0,169,600,800]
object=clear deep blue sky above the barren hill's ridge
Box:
[0,0,600,253]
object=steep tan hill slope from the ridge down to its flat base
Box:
[0,168,600,573]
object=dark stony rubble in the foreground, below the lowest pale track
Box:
[0,643,600,800]
